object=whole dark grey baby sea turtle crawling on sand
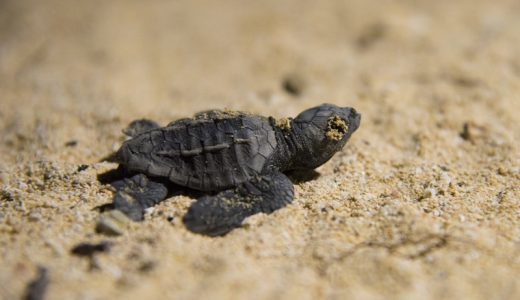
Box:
[104,104,361,236]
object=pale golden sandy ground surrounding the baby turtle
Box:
[0,0,520,299]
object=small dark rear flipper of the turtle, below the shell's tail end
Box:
[111,174,168,221]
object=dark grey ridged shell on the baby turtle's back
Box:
[121,112,277,191]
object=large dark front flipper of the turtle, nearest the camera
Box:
[183,173,294,236]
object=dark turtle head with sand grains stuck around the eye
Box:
[292,104,361,169]
